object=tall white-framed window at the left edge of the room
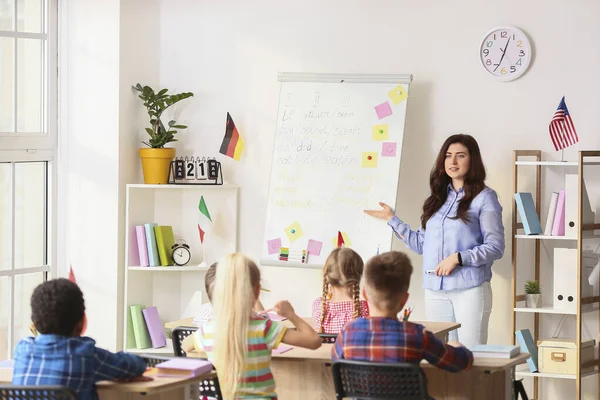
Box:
[0,0,58,360]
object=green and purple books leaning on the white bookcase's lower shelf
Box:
[127,304,167,349]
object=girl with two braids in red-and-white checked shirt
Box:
[312,247,369,333]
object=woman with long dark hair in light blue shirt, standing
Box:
[365,135,504,347]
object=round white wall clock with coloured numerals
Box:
[479,26,531,81]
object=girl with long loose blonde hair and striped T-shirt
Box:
[182,253,321,400]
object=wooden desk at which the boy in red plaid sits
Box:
[271,344,529,400]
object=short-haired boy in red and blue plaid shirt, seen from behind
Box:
[331,251,473,372]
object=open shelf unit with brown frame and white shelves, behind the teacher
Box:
[511,150,600,400]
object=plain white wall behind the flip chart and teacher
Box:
[154,0,600,398]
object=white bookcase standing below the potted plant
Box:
[122,184,238,354]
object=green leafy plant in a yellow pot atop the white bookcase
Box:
[133,83,194,184]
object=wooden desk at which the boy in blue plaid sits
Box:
[0,367,216,400]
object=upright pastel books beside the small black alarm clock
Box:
[135,223,175,267]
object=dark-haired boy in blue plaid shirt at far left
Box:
[12,279,146,400]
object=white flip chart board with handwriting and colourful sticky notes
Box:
[261,74,412,268]
